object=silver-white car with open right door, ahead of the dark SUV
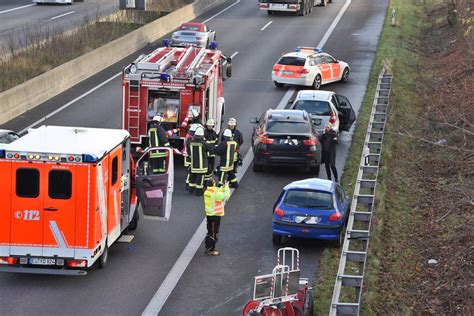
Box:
[289,90,355,134]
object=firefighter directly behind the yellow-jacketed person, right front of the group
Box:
[216,129,239,188]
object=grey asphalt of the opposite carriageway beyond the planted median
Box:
[0,0,118,52]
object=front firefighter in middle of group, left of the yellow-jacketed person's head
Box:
[188,126,214,195]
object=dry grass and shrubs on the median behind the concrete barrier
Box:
[0,0,192,92]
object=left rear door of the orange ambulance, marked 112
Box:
[10,161,47,256]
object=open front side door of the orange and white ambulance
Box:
[135,147,174,221]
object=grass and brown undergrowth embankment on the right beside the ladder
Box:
[314,0,474,315]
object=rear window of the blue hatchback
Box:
[283,190,333,209]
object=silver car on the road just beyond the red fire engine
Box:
[171,22,216,47]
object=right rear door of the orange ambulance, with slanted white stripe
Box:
[43,163,76,257]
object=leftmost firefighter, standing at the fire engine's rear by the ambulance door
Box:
[148,115,170,174]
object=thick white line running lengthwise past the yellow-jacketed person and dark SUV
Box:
[142,0,351,316]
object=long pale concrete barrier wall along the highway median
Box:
[0,0,224,124]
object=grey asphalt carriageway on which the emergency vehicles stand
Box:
[0,0,388,315]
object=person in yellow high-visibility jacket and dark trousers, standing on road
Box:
[204,178,230,256]
